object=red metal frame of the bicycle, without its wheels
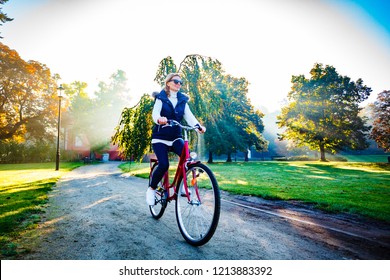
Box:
[150,121,200,203]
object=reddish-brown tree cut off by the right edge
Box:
[370,90,390,152]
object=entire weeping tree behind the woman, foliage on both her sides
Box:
[113,54,268,162]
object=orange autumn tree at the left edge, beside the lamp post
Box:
[0,43,58,142]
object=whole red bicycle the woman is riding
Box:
[149,120,221,246]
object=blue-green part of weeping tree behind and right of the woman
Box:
[155,54,268,162]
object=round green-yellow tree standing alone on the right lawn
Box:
[277,63,371,161]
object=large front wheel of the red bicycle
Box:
[176,162,221,246]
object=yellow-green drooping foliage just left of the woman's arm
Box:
[112,94,154,161]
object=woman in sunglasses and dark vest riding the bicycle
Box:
[146,73,206,205]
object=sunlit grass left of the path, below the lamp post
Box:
[0,163,81,256]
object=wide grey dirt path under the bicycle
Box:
[16,163,390,260]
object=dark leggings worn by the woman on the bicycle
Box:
[150,139,184,189]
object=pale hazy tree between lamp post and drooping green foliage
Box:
[64,70,130,157]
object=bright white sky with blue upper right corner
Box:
[0,0,390,113]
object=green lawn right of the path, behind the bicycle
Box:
[122,161,390,222]
